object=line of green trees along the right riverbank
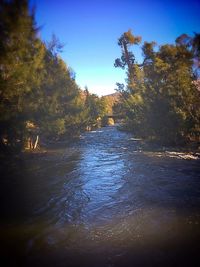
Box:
[114,30,200,144]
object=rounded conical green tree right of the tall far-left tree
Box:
[32,46,82,139]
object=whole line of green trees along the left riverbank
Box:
[0,0,106,152]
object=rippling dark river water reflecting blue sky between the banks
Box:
[0,126,200,267]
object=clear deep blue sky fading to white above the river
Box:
[31,0,200,95]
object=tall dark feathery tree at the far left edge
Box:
[0,0,42,151]
